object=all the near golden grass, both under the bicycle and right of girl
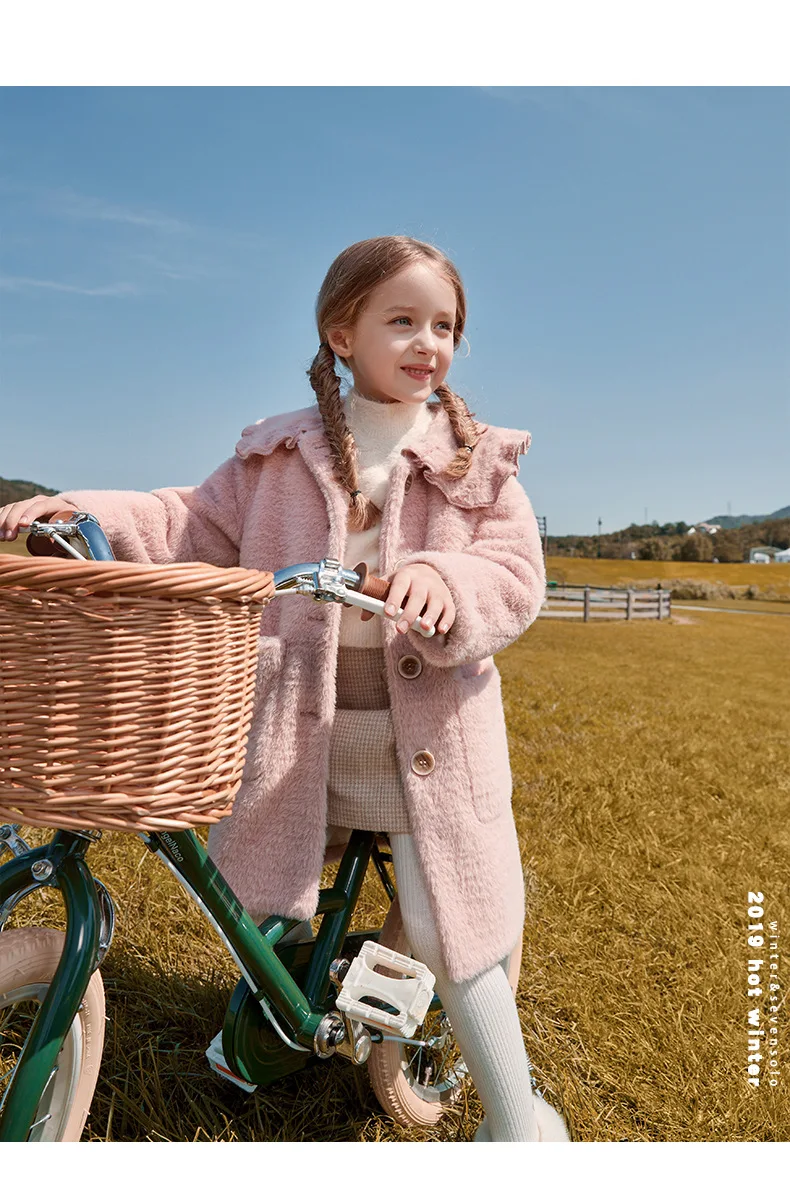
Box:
[3,604,790,1142]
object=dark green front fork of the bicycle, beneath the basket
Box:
[0,826,106,1142]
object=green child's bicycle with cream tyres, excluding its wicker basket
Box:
[0,513,521,1141]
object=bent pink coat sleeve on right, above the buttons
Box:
[393,476,546,667]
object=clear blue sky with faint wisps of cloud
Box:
[0,86,790,534]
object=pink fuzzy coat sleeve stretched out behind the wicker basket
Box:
[60,455,256,566]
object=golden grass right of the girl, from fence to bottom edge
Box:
[498,612,790,1141]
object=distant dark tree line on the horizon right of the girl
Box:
[548,517,790,562]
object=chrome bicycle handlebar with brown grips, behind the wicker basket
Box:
[19,511,436,639]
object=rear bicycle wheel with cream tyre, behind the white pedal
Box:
[367,896,521,1128]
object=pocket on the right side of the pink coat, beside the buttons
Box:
[455,657,512,822]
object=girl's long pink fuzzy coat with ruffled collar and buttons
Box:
[64,403,546,980]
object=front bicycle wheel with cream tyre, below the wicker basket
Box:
[0,927,104,1142]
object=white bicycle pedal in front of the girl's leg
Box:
[338,939,436,1037]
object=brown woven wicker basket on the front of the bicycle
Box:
[0,556,274,831]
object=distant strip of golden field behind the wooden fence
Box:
[547,557,790,602]
